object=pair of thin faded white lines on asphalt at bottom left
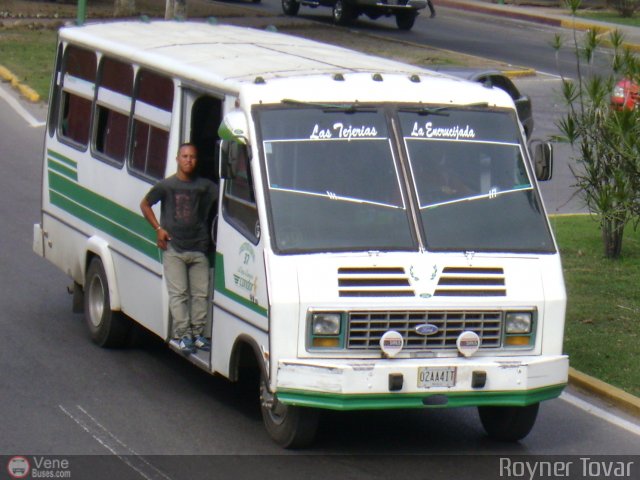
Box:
[58,405,171,480]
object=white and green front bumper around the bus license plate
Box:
[275,355,569,410]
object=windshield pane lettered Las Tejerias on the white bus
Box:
[260,108,417,252]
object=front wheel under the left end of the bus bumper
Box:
[260,374,319,449]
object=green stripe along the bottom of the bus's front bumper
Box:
[277,384,566,411]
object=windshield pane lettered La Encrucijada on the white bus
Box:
[399,109,555,252]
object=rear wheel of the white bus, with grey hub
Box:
[84,258,131,348]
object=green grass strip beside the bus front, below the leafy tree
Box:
[551,215,640,396]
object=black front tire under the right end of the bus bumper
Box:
[478,403,540,442]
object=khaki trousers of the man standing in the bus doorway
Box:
[162,244,209,338]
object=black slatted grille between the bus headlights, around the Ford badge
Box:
[347,311,503,350]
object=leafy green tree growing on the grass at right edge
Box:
[553,0,640,258]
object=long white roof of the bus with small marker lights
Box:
[60,21,512,107]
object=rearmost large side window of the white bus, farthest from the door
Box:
[58,46,97,149]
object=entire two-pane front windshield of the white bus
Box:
[256,105,555,253]
